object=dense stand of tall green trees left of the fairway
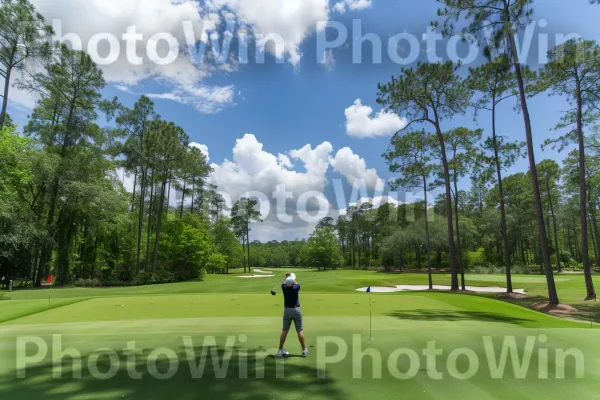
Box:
[0,0,270,286]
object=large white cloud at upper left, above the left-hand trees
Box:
[27,0,234,113]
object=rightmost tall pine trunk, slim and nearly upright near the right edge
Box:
[575,71,596,300]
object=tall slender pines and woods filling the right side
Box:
[304,0,600,304]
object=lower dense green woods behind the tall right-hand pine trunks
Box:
[315,150,600,281]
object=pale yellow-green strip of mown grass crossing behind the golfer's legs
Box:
[1,292,580,328]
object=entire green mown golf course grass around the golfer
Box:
[0,270,600,400]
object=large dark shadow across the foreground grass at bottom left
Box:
[0,346,347,400]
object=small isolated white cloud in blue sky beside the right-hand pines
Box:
[345,99,407,138]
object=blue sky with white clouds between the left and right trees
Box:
[5,0,600,240]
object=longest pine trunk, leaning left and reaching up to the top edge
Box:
[505,33,556,305]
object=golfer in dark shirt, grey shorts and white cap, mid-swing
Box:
[277,272,308,357]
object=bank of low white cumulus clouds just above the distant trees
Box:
[116,134,390,241]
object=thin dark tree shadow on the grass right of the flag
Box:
[387,309,532,325]
